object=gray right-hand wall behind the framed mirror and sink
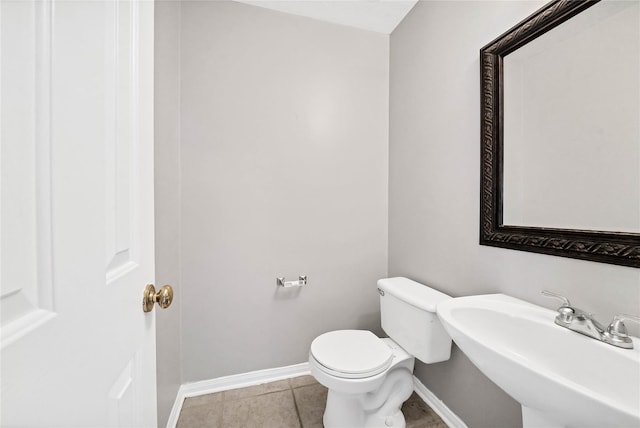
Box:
[389,1,640,428]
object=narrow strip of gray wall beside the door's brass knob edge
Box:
[154,1,182,426]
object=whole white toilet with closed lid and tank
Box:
[309,277,451,428]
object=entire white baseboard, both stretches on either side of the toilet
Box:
[167,363,467,428]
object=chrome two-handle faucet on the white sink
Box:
[542,290,640,349]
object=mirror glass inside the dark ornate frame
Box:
[502,1,640,233]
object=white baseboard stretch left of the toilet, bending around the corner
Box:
[167,363,311,428]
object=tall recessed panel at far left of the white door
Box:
[0,3,53,344]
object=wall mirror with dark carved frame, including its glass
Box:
[480,0,640,267]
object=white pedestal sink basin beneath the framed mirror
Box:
[437,294,640,428]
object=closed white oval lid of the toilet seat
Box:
[311,330,393,378]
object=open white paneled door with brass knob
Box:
[0,0,156,427]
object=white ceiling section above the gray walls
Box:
[235,0,417,34]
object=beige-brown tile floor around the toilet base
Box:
[177,376,447,428]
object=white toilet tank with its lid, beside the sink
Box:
[378,277,451,363]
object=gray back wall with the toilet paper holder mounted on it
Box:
[181,1,389,382]
